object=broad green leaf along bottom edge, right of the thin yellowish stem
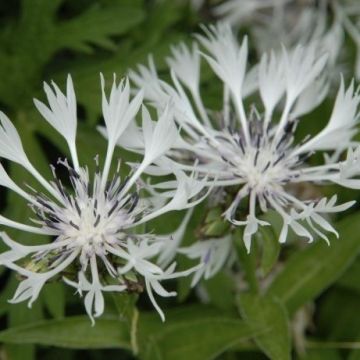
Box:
[139,305,259,360]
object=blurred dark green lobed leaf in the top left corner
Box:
[0,0,145,110]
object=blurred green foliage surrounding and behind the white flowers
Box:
[0,0,360,360]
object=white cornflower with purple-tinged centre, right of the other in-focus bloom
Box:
[128,25,360,262]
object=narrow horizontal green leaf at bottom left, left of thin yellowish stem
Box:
[0,316,131,349]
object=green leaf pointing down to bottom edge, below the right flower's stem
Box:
[238,294,291,360]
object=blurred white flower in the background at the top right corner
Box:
[213,0,360,78]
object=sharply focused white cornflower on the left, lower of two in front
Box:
[0,77,204,321]
